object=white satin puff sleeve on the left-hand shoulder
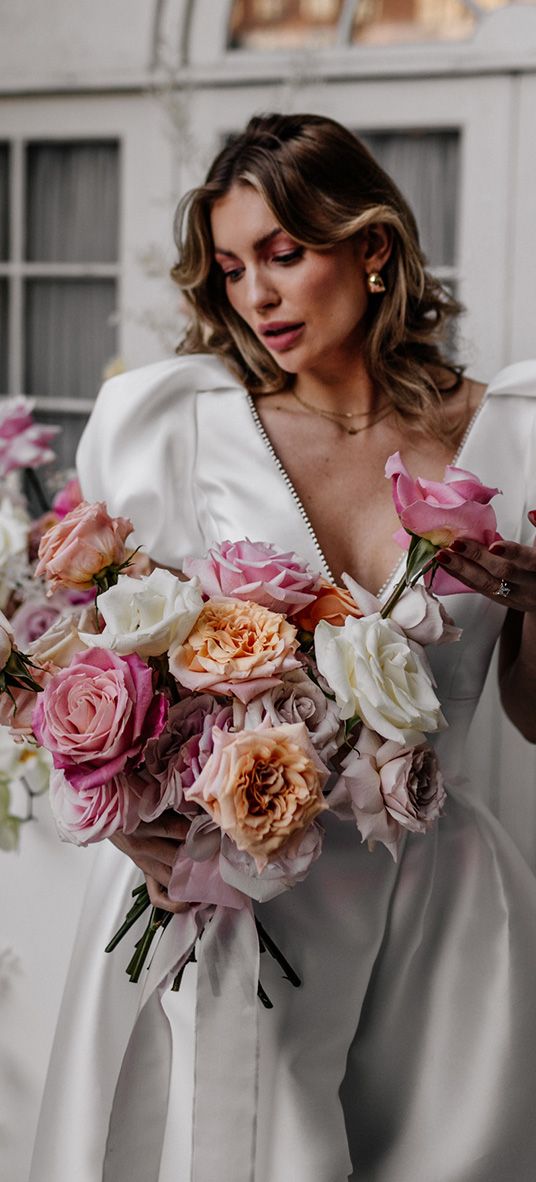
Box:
[77,357,208,566]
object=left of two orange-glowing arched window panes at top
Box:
[228,0,343,50]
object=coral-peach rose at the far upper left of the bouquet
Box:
[35,501,133,590]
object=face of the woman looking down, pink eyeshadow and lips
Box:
[212,184,374,376]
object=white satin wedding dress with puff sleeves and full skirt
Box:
[31,357,536,1182]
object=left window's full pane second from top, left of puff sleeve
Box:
[25,279,117,398]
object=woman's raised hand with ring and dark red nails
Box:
[437,538,536,612]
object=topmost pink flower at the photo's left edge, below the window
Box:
[0,395,59,478]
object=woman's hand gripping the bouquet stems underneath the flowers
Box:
[110,812,190,911]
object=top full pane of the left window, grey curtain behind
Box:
[26,143,118,262]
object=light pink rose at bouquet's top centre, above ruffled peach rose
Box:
[183,538,319,616]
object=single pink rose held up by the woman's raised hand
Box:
[386,452,501,595]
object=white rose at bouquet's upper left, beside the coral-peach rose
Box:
[80,567,204,657]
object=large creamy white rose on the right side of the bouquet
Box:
[315,612,446,746]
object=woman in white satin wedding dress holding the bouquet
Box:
[32,115,536,1182]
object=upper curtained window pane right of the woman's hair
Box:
[359,131,459,268]
